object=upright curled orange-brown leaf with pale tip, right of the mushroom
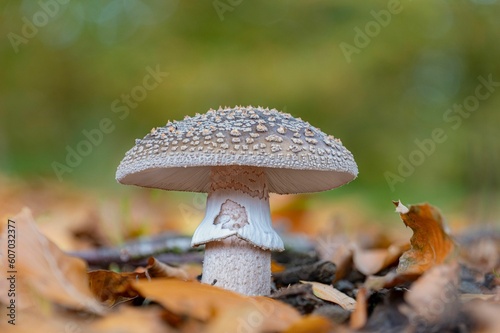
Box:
[394,201,455,274]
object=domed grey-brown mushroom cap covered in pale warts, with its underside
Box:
[116,106,358,194]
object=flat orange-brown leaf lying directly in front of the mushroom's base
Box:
[132,278,300,332]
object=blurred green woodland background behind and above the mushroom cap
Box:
[0,0,500,219]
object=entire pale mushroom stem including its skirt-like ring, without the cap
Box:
[192,166,283,295]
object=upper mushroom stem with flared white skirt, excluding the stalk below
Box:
[191,166,284,251]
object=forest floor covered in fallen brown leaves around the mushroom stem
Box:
[0,177,500,333]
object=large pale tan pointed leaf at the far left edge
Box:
[0,208,105,314]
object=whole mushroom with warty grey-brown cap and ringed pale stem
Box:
[116,106,358,295]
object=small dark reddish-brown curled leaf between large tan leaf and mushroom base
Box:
[88,270,146,307]
